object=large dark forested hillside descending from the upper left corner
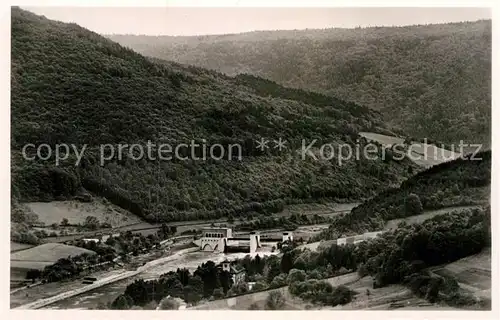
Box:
[11,8,414,221]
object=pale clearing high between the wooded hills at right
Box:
[359,132,459,167]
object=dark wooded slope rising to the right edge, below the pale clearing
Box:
[318,151,491,239]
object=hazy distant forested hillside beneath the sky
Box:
[109,21,491,144]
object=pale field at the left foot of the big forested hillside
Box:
[26,198,146,227]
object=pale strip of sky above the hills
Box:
[22,7,491,36]
